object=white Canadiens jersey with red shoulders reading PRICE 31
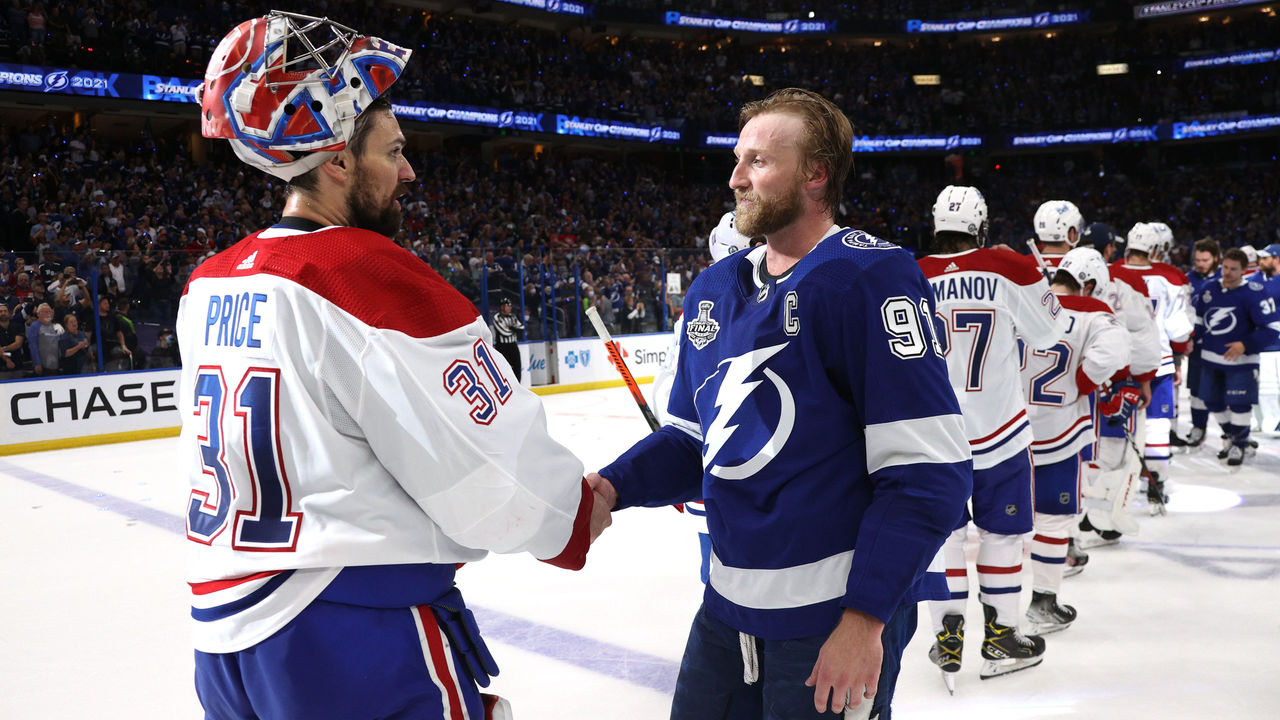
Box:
[177,227,591,652]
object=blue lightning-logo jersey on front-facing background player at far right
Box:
[1194,274,1280,368]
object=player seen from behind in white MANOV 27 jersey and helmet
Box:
[920,186,1064,685]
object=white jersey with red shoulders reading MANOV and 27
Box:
[919,249,1065,470]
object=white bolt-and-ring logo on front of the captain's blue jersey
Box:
[699,342,795,480]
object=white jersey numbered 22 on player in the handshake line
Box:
[1021,295,1129,465]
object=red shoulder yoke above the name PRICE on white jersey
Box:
[183,227,480,338]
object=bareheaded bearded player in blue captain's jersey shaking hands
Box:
[588,88,970,720]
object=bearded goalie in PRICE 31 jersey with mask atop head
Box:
[177,12,608,719]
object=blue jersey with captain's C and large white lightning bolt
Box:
[600,227,973,638]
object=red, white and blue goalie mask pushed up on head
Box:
[197,10,411,181]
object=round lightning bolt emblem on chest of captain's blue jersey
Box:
[694,342,796,480]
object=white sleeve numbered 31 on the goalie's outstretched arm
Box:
[325,311,594,569]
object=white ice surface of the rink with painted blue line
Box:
[0,388,1280,720]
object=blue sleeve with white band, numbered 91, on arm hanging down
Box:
[831,251,973,621]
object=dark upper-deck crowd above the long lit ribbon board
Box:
[0,0,1280,135]
